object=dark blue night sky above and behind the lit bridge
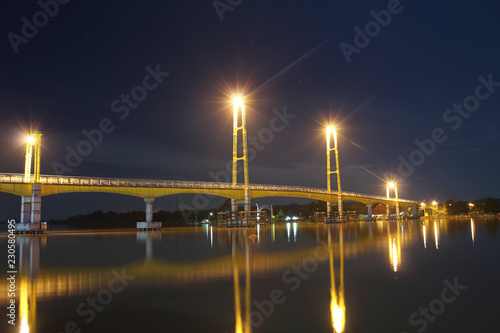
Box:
[0,0,500,219]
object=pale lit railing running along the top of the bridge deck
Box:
[0,173,417,204]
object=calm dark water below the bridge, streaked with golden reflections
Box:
[0,219,500,333]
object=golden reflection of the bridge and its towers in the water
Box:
[0,220,458,333]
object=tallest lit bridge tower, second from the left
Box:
[231,97,251,218]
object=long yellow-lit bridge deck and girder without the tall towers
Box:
[0,173,418,226]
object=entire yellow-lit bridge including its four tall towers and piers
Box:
[0,97,418,227]
